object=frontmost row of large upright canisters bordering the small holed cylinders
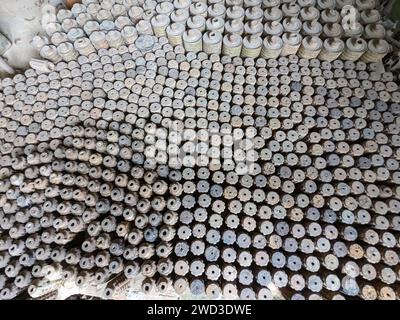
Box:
[167,29,389,62]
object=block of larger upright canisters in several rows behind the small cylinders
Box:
[41,0,390,62]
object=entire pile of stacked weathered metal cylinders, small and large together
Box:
[0,0,400,300]
